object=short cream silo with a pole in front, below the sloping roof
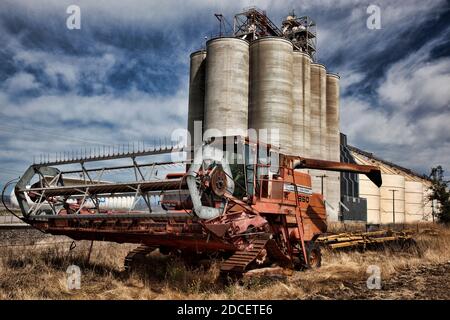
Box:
[380,174,405,223]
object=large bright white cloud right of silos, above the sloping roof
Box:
[341,26,450,172]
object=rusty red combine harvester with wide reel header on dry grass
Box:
[15,136,381,274]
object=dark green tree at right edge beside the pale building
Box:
[429,166,450,224]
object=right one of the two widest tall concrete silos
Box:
[249,37,293,154]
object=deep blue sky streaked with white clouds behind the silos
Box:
[0,0,450,189]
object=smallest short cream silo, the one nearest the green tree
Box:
[405,181,424,222]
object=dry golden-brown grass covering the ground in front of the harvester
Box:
[0,222,450,299]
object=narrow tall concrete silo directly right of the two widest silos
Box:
[292,51,311,157]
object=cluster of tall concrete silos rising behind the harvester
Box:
[188,37,340,219]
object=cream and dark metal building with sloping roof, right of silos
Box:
[341,134,433,224]
